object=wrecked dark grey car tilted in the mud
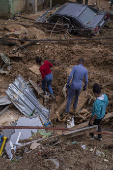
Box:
[36,3,110,35]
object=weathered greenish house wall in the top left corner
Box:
[0,0,27,18]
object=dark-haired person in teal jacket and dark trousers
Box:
[89,83,108,140]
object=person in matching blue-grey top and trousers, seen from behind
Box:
[65,59,88,113]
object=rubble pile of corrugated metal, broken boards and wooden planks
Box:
[0,70,113,159]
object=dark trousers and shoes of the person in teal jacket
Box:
[89,118,103,138]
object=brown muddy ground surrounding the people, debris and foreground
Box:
[0,5,113,170]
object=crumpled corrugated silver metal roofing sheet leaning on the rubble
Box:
[6,75,49,123]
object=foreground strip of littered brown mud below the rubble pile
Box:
[0,136,113,170]
